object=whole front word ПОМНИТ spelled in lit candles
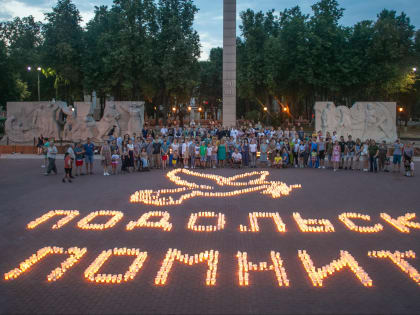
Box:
[4,246,420,287]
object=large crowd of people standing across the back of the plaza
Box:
[38,125,414,182]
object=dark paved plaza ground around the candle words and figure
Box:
[0,159,420,314]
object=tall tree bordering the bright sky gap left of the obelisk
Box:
[153,0,200,117]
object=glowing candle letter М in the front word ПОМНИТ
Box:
[155,248,219,286]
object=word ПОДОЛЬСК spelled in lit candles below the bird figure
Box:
[27,210,420,233]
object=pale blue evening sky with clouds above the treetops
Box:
[0,0,420,60]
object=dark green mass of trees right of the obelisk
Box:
[238,0,420,122]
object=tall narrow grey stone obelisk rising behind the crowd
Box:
[223,0,236,127]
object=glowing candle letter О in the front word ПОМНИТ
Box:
[84,247,147,283]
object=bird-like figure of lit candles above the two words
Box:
[130,169,302,206]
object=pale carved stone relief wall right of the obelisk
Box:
[314,102,397,143]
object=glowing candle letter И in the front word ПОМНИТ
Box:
[298,250,372,287]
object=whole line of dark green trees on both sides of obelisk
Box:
[0,0,420,121]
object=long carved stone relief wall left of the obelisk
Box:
[2,101,144,144]
